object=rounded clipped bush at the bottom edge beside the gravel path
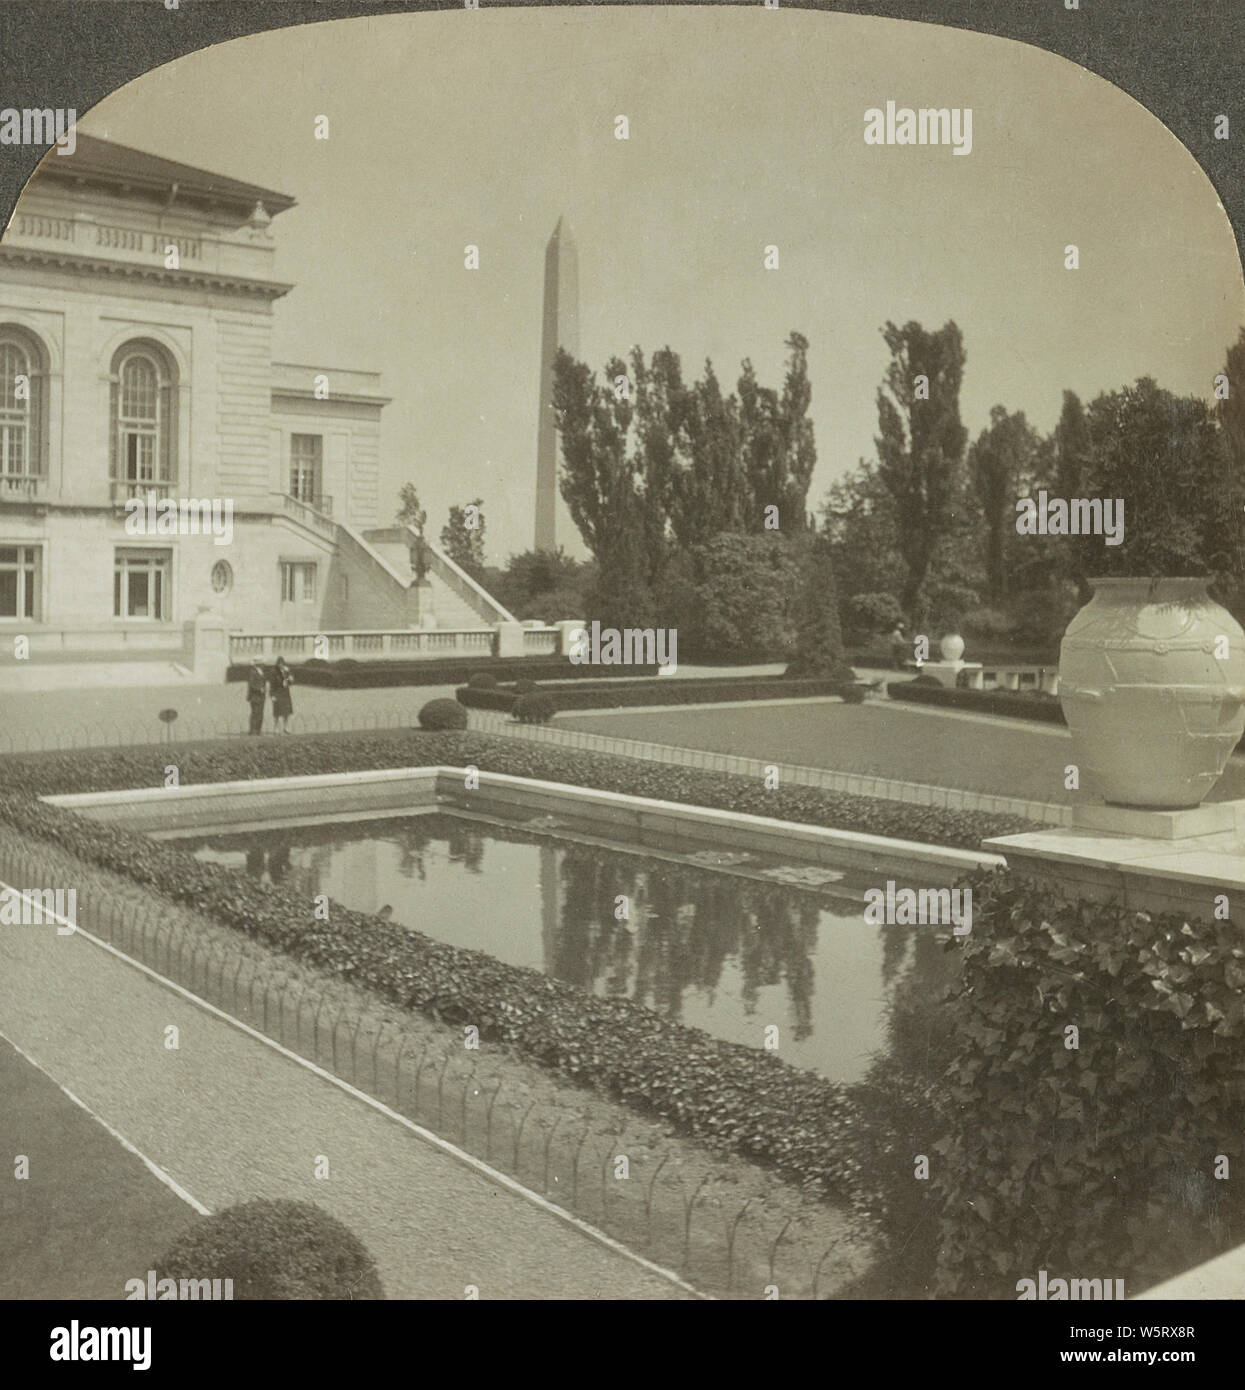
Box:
[154,1200,385,1300]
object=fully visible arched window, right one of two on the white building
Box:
[111,341,178,496]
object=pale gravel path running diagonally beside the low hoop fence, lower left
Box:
[0,889,689,1300]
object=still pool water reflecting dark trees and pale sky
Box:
[183,812,952,1081]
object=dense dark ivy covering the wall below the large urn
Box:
[928,873,1245,1298]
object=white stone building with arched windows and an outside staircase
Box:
[0,135,513,667]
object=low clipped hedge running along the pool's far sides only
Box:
[0,730,1038,849]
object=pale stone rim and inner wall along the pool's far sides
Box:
[43,765,1006,872]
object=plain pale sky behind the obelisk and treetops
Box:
[81,4,1245,562]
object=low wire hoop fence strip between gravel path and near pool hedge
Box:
[0,827,871,1300]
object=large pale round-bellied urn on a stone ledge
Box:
[1059,578,1245,809]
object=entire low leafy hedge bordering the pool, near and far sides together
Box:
[0,750,1034,1206]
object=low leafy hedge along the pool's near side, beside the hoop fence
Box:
[0,795,856,1200]
